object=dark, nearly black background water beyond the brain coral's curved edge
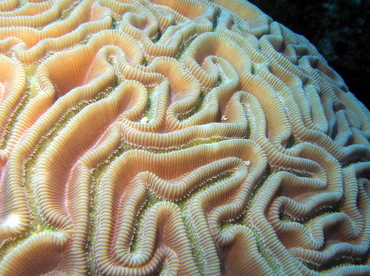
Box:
[250,0,370,109]
